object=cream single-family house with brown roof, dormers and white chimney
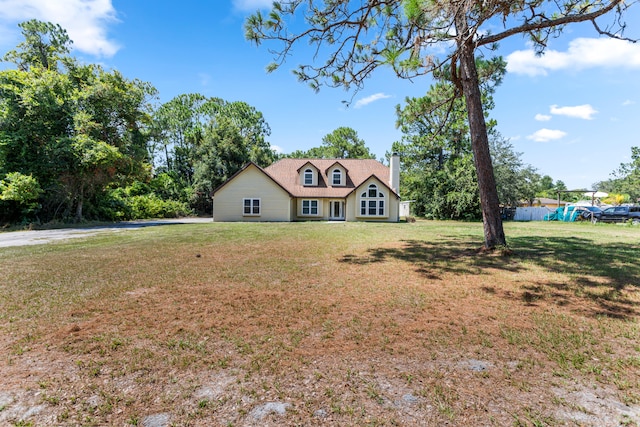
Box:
[213,154,400,222]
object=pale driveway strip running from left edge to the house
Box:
[0,218,213,248]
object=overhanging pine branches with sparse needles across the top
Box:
[245,0,634,95]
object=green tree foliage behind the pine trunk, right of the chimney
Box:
[393,58,537,220]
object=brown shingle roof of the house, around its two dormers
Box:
[264,159,396,198]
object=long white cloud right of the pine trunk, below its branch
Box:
[507,38,640,76]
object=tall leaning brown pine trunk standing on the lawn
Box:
[458,42,506,249]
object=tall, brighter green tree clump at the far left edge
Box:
[0,21,155,221]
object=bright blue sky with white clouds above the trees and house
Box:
[0,0,640,188]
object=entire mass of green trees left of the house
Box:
[0,20,277,226]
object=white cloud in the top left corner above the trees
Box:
[0,0,120,57]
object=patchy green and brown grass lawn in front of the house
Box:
[0,221,640,427]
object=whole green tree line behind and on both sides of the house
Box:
[0,20,640,227]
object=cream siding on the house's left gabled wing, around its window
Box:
[213,165,292,222]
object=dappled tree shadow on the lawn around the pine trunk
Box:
[340,236,640,319]
